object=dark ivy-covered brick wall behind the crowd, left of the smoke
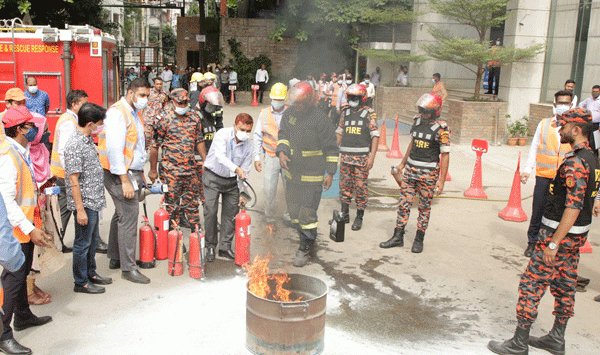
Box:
[219,18,298,81]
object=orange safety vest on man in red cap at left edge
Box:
[0,140,42,243]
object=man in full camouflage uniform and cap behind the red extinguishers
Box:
[148,89,206,227]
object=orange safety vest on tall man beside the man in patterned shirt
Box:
[98,99,144,170]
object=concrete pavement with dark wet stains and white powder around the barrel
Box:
[15,106,600,354]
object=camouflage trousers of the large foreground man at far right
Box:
[517,227,587,328]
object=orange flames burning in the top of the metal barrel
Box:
[244,256,302,302]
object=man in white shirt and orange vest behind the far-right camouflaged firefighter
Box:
[521,90,573,257]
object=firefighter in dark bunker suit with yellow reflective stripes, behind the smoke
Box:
[276,81,338,267]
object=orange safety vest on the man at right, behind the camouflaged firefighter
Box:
[535,118,571,179]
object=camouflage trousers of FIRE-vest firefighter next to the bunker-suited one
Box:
[340,158,369,210]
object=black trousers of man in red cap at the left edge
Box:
[0,242,34,341]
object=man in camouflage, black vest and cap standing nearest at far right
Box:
[488,108,600,354]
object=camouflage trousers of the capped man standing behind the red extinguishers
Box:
[160,169,204,226]
